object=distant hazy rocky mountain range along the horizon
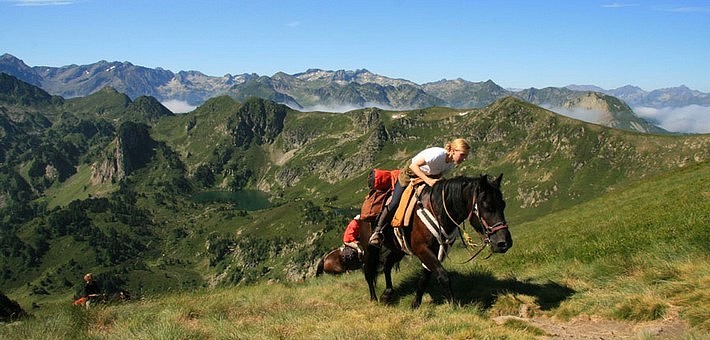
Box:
[5,54,710,133]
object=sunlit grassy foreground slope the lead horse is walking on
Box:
[0,162,710,339]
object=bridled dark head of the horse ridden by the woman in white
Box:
[469,174,513,253]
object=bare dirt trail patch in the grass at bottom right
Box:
[494,311,689,339]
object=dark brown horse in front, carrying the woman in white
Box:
[364,174,513,308]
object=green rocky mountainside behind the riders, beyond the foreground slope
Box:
[0,89,710,304]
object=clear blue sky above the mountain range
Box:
[0,0,710,92]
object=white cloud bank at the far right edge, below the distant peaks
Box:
[634,105,710,133]
